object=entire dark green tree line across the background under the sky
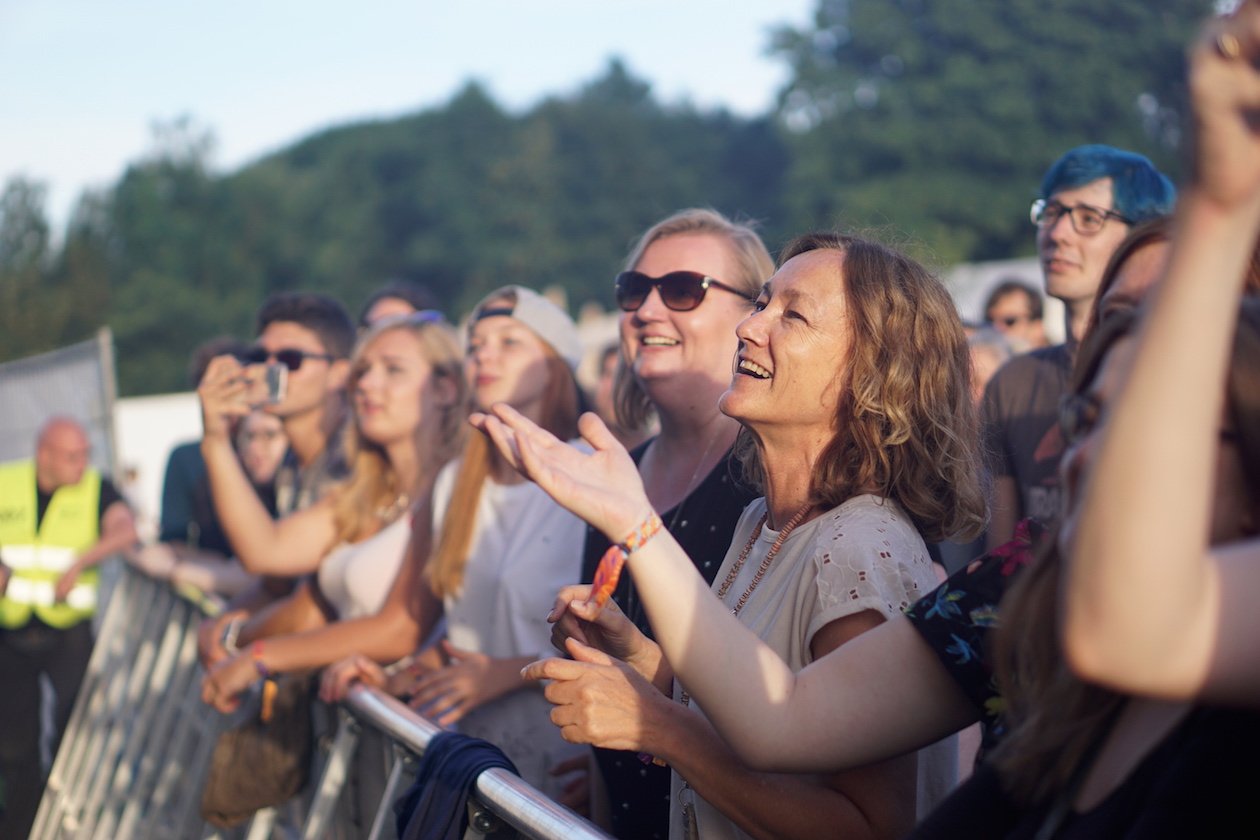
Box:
[0,0,1210,395]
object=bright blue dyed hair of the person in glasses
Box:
[1041,144,1177,224]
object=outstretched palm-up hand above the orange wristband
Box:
[471,403,651,542]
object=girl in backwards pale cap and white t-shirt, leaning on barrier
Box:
[324,286,586,797]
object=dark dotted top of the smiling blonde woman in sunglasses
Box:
[582,441,761,840]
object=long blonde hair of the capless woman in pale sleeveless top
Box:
[333,315,469,545]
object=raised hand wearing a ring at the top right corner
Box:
[1189,0,1260,210]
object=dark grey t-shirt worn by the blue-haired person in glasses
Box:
[980,344,1072,525]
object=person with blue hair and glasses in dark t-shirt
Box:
[982,145,1176,548]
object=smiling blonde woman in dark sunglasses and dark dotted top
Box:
[574,209,774,840]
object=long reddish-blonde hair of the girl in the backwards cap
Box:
[425,296,578,598]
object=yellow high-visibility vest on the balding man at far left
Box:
[0,460,101,630]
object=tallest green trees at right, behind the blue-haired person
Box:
[775,0,1210,264]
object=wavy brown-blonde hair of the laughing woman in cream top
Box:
[736,232,987,542]
